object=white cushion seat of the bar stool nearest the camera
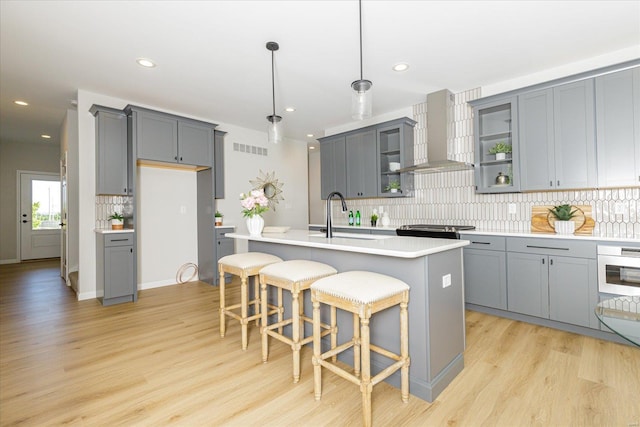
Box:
[312,266,409,304]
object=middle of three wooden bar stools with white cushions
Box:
[260,260,337,383]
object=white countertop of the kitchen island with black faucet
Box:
[226,230,469,258]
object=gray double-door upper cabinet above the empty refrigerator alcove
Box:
[125,105,216,167]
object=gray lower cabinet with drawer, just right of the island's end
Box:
[460,234,507,310]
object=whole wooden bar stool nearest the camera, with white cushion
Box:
[311,271,410,426]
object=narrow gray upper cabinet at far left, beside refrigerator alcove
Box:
[90,105,131,196]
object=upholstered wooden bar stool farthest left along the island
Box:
[218,252,282,350]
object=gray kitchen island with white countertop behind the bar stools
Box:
[227,230,469,402]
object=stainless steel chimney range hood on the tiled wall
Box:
[399,89,473,173]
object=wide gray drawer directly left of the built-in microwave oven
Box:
[507,237,596,259]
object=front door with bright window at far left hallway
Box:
[19,172,61,261]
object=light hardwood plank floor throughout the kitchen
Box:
[0,260,640,427]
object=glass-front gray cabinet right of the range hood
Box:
[470,96,520,193]
